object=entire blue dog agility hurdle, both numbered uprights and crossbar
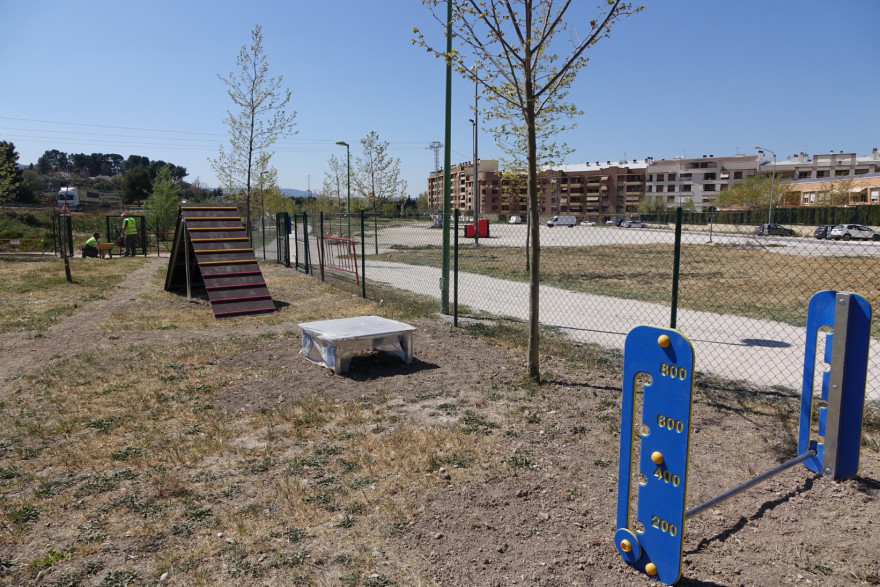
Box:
[614,291,871,585]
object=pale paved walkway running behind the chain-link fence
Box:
[366,261,880,400]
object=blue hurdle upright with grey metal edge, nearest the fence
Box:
[798,291,871,481]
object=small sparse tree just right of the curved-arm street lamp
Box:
[351,131,406,212]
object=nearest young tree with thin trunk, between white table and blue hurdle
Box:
[414,0,641,380]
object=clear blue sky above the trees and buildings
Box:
[0,0,880,196]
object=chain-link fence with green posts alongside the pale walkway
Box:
[256,215,880,415]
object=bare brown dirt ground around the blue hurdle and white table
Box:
[0,260,880,586]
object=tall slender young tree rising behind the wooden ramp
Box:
[211,25,296,234]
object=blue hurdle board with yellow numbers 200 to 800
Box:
[614,326,694,585]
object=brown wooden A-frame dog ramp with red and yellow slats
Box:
[165,206,275,318]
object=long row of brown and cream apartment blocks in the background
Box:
[428,148,880,220]
